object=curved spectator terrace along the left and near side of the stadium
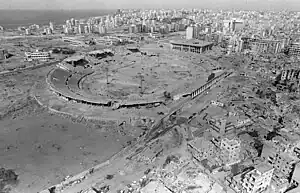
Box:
[47,64,163,108]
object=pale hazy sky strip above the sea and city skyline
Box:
[0,0,300,11]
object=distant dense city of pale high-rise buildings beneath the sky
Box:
[0,9,300,55]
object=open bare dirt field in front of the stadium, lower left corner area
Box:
[0,68,128,193]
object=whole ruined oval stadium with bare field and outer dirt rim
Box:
[34,44,223,124]
